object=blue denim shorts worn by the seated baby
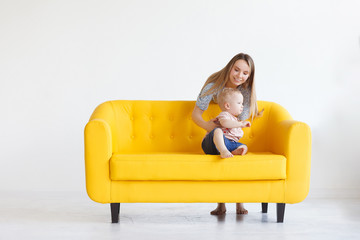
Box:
[201,128,245,155]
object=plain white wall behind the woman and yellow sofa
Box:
[0,0,360,195]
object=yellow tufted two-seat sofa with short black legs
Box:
[85,100,311,222]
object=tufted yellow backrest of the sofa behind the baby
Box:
[91,100,288,153]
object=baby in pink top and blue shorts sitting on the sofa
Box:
[201,88,251,158]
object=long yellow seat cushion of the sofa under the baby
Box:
[110,152,286,181]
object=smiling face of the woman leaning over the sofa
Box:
[226,59,250,88]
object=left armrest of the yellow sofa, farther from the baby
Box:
[84,119,112,203]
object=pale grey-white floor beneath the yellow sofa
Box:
[0,192,360,240]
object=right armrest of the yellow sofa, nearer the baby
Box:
[270,120,311,203]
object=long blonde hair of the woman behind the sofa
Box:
[201,53,263,121]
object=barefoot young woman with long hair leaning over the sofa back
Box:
[192,53,262,215]
